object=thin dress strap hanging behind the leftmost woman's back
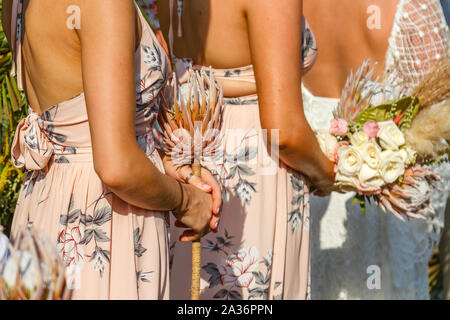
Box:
[11,0,23,91]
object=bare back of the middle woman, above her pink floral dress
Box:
[157,0,251,69]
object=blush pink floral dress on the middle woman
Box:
[153,0,317,300]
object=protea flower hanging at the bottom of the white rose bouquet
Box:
[374,165,440,221]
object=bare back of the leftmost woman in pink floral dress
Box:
[3,0,140,113]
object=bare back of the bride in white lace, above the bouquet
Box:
[303,0,398,98]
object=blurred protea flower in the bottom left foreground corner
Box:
[0,225,71,300]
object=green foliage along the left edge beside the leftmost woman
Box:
[0,0,27,235]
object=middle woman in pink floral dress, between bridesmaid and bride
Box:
[158,0,334,299]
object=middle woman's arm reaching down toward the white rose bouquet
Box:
[242,0,334,188]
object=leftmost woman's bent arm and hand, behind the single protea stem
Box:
[77,0,212,238]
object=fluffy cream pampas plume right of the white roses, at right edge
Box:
[404,98,450,159]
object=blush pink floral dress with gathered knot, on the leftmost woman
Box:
[8,0,169,299]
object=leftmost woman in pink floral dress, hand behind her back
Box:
[3,0,220,299]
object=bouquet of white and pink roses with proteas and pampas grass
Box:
[317,57,450,220]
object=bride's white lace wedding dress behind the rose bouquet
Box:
[303,0,450,299]
